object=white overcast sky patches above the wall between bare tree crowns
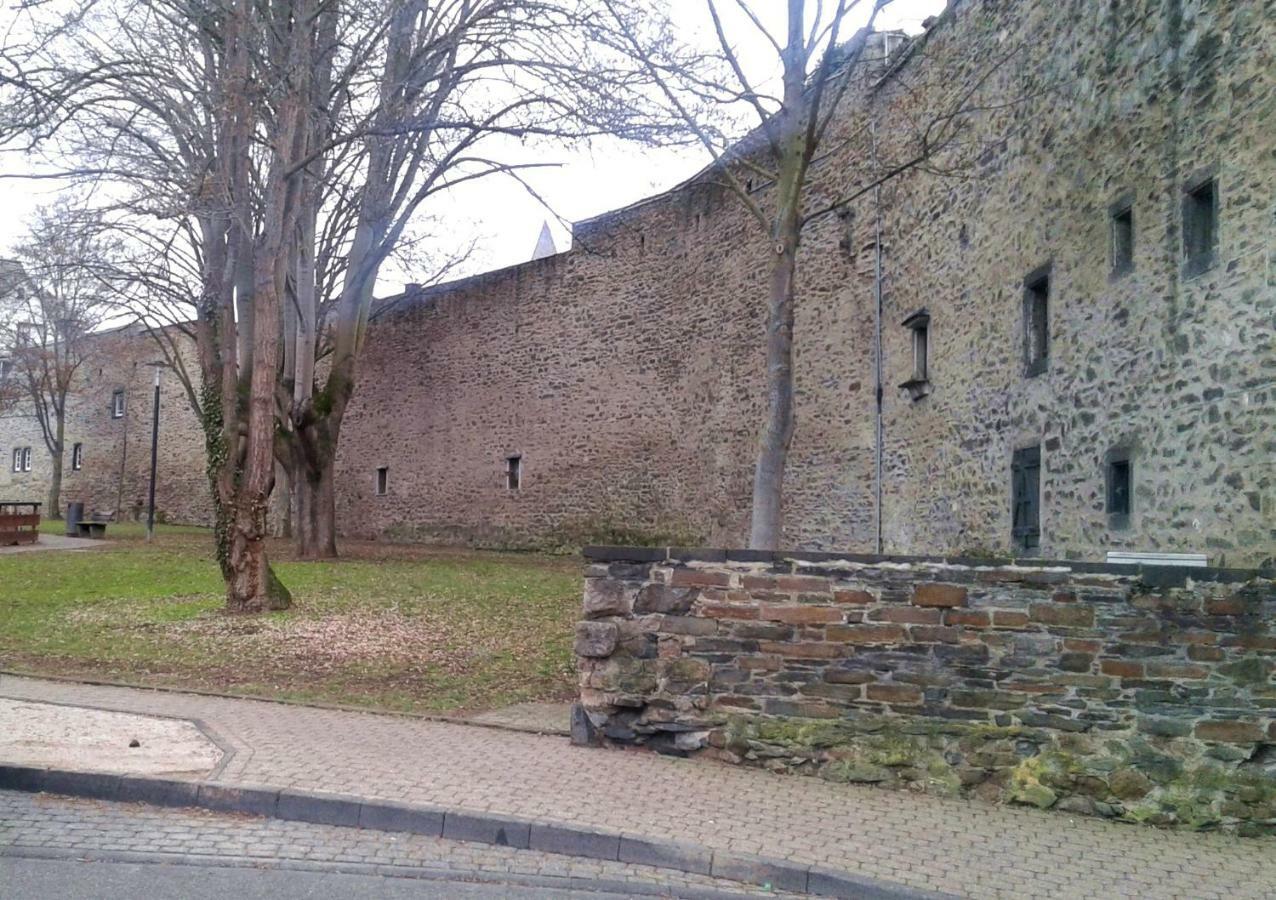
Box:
[0,0,944,294]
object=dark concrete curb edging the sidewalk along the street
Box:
[0,765,949,900]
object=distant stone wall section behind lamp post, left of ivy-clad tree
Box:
[0,331,212,525]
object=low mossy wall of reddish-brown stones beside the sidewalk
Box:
[573,548,1276,832]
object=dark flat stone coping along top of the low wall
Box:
[583,546,1276,587]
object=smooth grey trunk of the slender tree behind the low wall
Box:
[749,241,798,550]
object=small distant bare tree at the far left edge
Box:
[0,199,115,518]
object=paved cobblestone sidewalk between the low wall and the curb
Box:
[0,677,1276,900]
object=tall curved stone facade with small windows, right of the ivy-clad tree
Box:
[0,0,1276,566]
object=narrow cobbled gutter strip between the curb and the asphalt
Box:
[0,790,775,896]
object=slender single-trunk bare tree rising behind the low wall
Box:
[605,0,1004,549]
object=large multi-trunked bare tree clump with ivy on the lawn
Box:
[0,0,689,611]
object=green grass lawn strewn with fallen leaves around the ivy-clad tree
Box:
[0,522,581,712]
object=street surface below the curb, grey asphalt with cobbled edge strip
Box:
[0,790,776,900]
